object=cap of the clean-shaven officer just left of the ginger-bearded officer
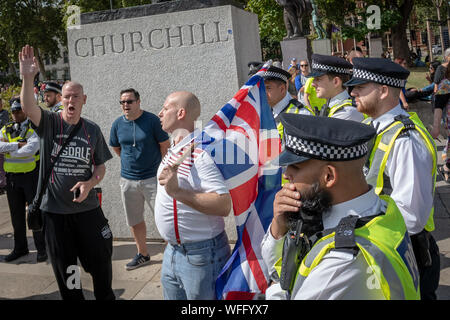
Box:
[308,54,353,77]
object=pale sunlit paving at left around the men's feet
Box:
[0,195,164,300]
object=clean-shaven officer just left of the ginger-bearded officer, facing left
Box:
[309,54,364,122]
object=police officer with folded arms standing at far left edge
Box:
[0,99,47,262]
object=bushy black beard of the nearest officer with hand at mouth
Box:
[286,182,332,236]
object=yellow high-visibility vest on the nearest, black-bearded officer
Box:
[275,196,420,300]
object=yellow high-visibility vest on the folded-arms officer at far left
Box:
[2,123,39,173]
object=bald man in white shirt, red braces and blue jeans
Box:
[155,91,231,300]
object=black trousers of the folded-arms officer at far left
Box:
[6,167,45,253]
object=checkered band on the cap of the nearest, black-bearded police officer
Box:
[285,134,368,161]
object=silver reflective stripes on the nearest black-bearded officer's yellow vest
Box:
[292,236,405,300]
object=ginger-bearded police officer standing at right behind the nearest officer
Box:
[345,58,440,299]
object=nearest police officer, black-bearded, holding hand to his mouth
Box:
[262,114,419,300]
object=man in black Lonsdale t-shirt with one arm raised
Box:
[19,45,115,300]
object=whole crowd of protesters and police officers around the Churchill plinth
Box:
[0,46,444,300]
